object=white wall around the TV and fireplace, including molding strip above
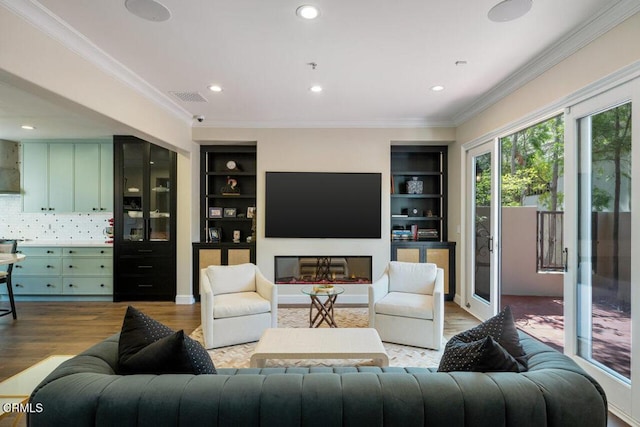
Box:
[194,127,454,303]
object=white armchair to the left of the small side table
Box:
[200,263,278,348]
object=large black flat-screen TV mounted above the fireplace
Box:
[265,172,382,239]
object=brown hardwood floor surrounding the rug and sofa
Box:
[0,302,628,427]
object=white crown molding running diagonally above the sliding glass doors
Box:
[452,0,640,126]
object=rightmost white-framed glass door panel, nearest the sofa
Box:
[565,83,640,417]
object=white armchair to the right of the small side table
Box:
[369,261,444,350]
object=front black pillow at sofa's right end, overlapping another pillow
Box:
[438,336,520,372]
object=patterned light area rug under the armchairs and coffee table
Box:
[190,307,444,368]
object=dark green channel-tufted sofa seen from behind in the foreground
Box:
[28,333,607,427]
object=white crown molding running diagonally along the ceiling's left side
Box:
[0,0,192,122]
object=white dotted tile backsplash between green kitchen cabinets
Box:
[0,194,113,242]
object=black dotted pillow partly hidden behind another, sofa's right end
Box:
[442,306,528,372]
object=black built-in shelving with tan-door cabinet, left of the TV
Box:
[193,143,259,300]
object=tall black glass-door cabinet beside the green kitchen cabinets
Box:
[113,136,177,301]
